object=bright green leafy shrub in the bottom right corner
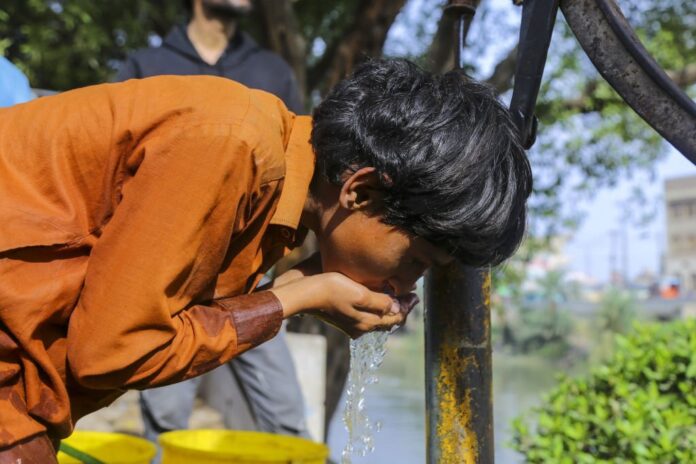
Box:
[513,319,696,464]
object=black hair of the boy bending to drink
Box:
[311,59,532,266]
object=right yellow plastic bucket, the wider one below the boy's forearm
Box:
[159,430,329,464]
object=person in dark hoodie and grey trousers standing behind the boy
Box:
[116,0,309,461]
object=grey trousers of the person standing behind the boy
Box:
[140,328,309,459]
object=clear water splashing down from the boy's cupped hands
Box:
[341,332,389,464]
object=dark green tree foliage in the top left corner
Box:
[0,0,184,90]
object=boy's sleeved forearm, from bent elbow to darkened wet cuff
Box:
[68,292,283,389]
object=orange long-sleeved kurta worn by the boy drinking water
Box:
[0,76,314,448]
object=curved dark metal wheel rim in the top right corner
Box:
[560,0,696,164]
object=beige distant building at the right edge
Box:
[665,176,696,294]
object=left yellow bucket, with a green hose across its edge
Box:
[58,430,157,464]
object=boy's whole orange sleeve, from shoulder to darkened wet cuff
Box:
[67,123,282,388]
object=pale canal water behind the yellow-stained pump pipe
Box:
[328,328,580,464]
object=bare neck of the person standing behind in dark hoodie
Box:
[186,2,237,65]
